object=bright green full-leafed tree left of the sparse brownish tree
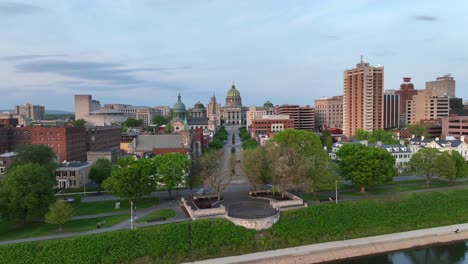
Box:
[154,153,190,198]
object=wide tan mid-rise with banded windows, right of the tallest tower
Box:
[406,90,450,124]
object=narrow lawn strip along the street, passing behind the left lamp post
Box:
[73,197,159,215]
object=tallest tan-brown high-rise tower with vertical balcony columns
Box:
[343,59,384,136]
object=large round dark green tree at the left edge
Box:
[0,163,55,225]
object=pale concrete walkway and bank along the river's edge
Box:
[190,224,468,264]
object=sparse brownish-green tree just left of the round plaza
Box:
[200,151,233,200]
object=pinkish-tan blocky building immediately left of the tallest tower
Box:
[315,95,343,131]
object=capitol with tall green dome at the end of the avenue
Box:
[223,84,245,126]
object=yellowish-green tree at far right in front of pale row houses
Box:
[408,148,456,185]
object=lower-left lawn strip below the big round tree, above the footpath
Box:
[0,214,130,240]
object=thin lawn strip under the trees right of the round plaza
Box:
[340,180,468,196]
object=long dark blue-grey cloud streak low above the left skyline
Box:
[16,60,190,90]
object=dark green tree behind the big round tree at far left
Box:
[9,145,57,174]
